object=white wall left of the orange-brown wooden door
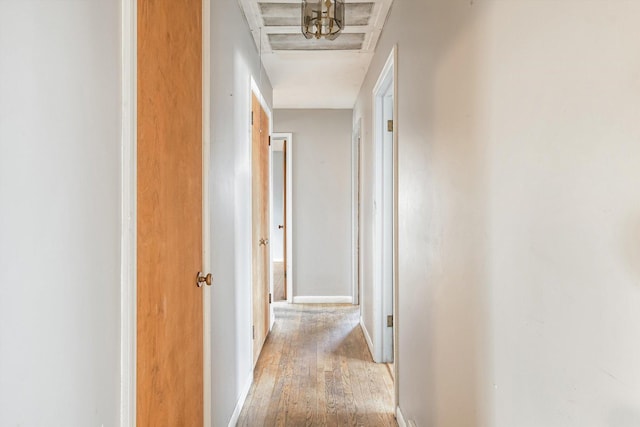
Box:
[0,0,121,426]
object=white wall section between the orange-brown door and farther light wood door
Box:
[209,0,272,426]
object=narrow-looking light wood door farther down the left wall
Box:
[251,94,270,363]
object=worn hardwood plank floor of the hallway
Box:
[237,303,397,427]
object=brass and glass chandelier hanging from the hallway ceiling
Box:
[302,0,344,40]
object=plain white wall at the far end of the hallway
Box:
[274,109,352,297]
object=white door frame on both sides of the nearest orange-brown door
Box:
[120,0,212,427]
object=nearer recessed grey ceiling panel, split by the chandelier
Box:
[258,3,373,27]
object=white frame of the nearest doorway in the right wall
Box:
[372,45,400,406]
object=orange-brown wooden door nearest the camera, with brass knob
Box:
[136,0,203,427]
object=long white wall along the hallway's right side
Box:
[354,0,640,427]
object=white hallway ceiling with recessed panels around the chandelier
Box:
[239,0,393,108]
